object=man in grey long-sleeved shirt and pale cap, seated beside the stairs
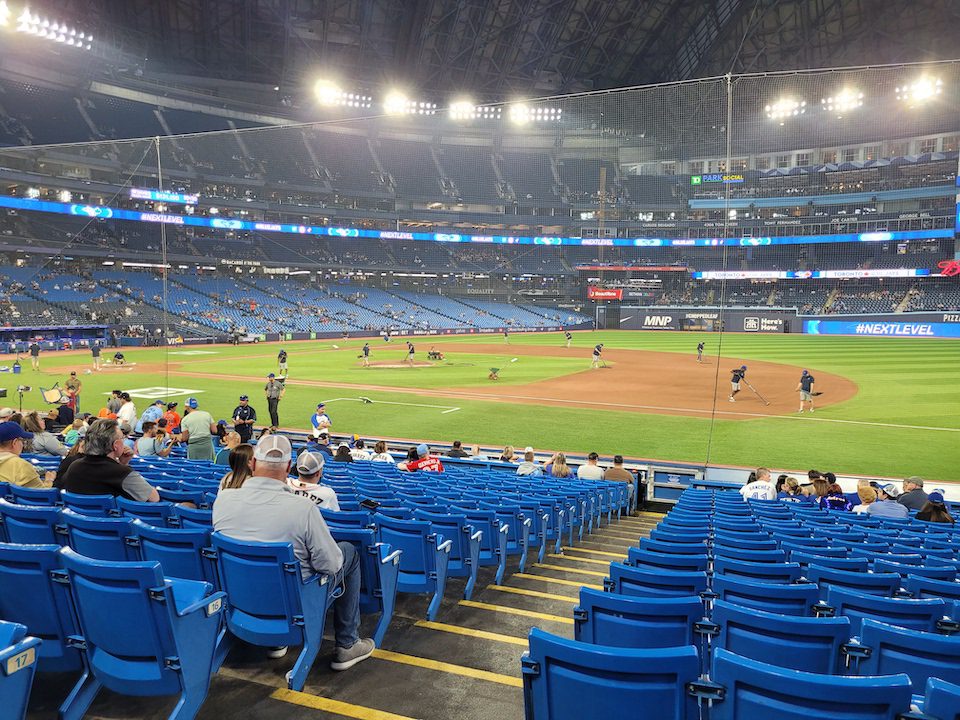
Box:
[213,435,375,670]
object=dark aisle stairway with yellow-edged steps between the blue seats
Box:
[29,512,662,720]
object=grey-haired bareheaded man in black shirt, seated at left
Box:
[63,418,160,502]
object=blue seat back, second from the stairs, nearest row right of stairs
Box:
[710,648,910,720]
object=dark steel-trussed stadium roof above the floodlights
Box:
[58,0,960,102]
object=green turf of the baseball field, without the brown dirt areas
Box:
[9,331,960,480]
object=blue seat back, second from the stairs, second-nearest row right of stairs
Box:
[710,600,850,675]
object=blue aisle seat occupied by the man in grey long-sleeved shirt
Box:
[210,532,330,690]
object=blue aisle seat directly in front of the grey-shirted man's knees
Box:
[330,527,401,647]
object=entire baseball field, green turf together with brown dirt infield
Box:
[9,331,960,480]
